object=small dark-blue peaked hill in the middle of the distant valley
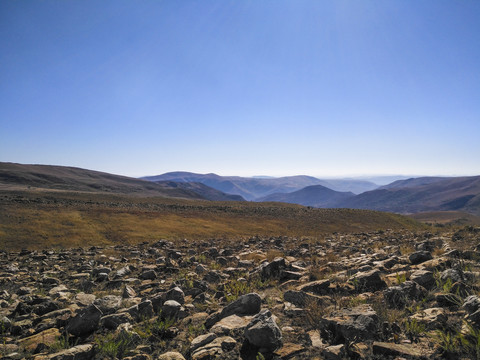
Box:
[258,185,355,208]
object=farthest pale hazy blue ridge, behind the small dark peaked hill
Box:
[142,172,378,200]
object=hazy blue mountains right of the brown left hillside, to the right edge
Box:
[144,172,480,215]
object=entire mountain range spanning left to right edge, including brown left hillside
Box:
[0,163,480,215]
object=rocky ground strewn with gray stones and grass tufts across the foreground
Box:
[0,227,480,360]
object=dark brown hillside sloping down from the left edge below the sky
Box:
[0,162,232,200]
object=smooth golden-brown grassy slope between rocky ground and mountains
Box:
[0,191,424,250]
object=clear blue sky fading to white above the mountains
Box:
[0,0,480,177]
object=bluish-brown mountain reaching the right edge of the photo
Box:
[336,176,480,215]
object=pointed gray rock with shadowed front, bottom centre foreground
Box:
[245,310,283,353]
